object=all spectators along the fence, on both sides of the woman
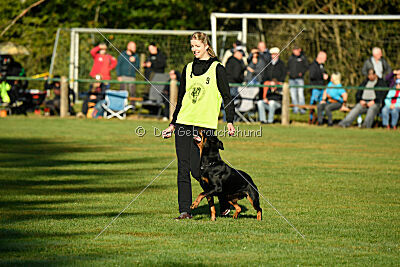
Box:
[1,38,400,129]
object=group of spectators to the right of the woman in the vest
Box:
[222,41,400,129]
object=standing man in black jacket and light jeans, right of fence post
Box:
[288,45,308,114]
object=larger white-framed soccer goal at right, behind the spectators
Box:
[210,13,400,85]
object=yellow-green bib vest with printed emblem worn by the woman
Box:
[176,61,222,129]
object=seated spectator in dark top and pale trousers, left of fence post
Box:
[257,79,282,123]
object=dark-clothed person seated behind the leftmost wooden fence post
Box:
[44,75,75,115]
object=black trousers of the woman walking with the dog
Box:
[175,124,229,213]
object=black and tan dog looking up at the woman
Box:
[190,132,262,221]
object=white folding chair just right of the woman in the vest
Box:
[235,86,260,124]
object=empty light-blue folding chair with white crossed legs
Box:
[101,90,133,120]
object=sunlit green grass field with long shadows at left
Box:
[0,117,400,266]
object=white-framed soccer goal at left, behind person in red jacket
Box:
[50,28,241,96]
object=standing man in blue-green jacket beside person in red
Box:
[116,42,140,97]
